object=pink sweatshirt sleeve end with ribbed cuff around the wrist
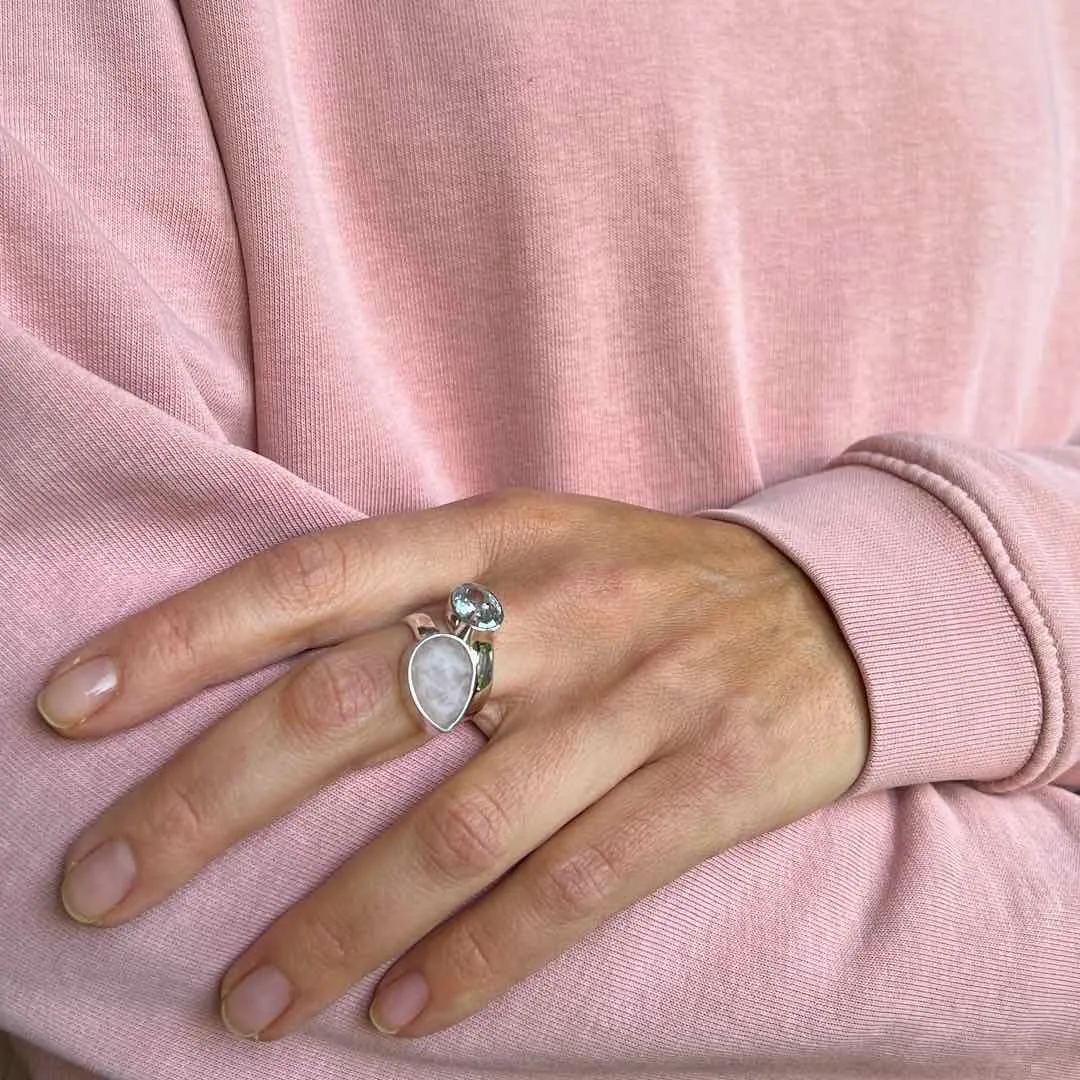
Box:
[703,434,1080,794]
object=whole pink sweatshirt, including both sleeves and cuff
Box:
[0,0,1080,1080]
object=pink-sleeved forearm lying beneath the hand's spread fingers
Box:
[0,337,1080,1077]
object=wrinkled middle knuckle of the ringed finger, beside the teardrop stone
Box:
[282,652,394,746]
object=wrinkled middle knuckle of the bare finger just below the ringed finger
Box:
[417,788,510,882]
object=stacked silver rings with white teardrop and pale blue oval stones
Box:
[402,581,502,732]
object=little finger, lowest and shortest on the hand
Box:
[370,756,717,1038]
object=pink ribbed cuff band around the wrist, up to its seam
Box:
[700,465,1042,795]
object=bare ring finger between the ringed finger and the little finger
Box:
[211,695,660,1038]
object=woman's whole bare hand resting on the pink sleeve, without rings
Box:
[39,490,868,1039]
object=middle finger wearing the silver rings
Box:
[54,609,544,927]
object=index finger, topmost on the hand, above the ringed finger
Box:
[38,495,540,738]
